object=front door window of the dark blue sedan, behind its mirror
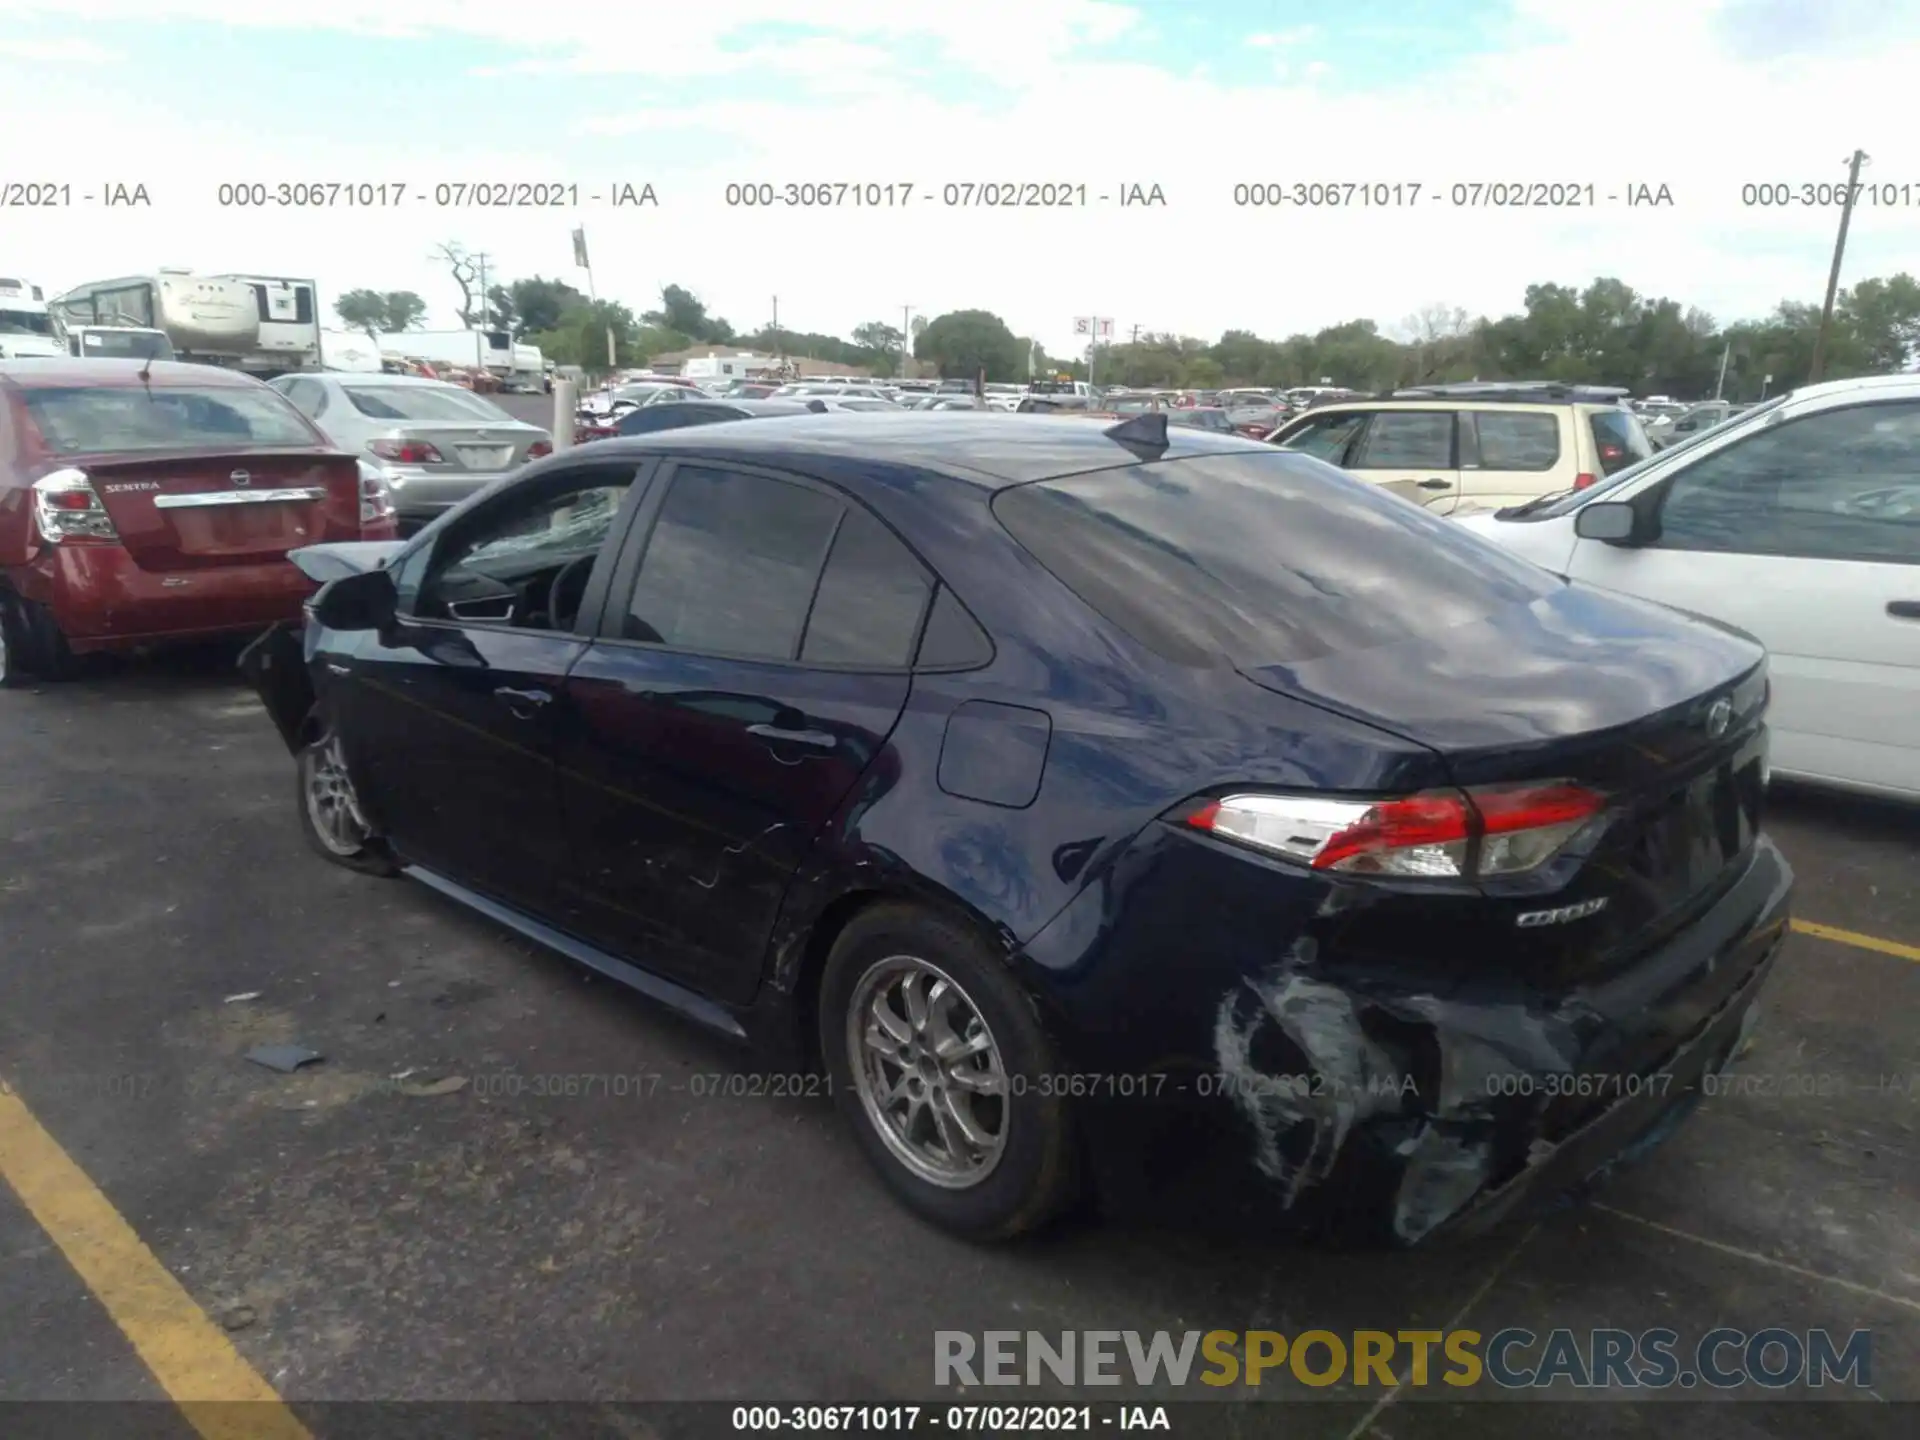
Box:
[407,480,634,630]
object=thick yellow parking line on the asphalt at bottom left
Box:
[0,1085,311,1440]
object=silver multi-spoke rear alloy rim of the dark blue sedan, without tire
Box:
[847,954,1010,1190]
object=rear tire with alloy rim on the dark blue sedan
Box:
[820,904,1079,1240]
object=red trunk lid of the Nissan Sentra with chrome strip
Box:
[77,449,361,570]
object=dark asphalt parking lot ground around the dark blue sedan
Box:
[0,656,1920,1440]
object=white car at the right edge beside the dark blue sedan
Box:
[1459,374,1920,801]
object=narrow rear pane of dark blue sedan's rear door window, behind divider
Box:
[801,509,933,666]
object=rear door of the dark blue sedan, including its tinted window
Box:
[561,461,933,1004]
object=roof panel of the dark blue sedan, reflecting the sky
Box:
[593,411,1277,490]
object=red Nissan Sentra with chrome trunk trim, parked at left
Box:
[0,359,396,684]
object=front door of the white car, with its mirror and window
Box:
[1571,401,1920,795]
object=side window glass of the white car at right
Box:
[1657,403,1920,564]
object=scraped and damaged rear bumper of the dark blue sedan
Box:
[1029,837,1793,1246]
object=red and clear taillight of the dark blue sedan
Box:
[1187,781,1607,879]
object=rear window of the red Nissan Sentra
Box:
[21,384,321,455]
